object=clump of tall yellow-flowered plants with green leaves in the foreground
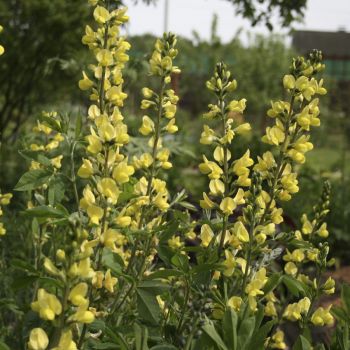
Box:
[0,0,344,350]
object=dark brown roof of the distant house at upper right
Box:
[292,30,350,59]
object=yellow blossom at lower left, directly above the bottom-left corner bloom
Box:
[31,288,62,321]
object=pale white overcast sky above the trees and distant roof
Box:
[125,0,350,42]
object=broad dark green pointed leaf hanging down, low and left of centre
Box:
[136,288,160,325]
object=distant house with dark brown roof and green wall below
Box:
[292,30,350,83]
